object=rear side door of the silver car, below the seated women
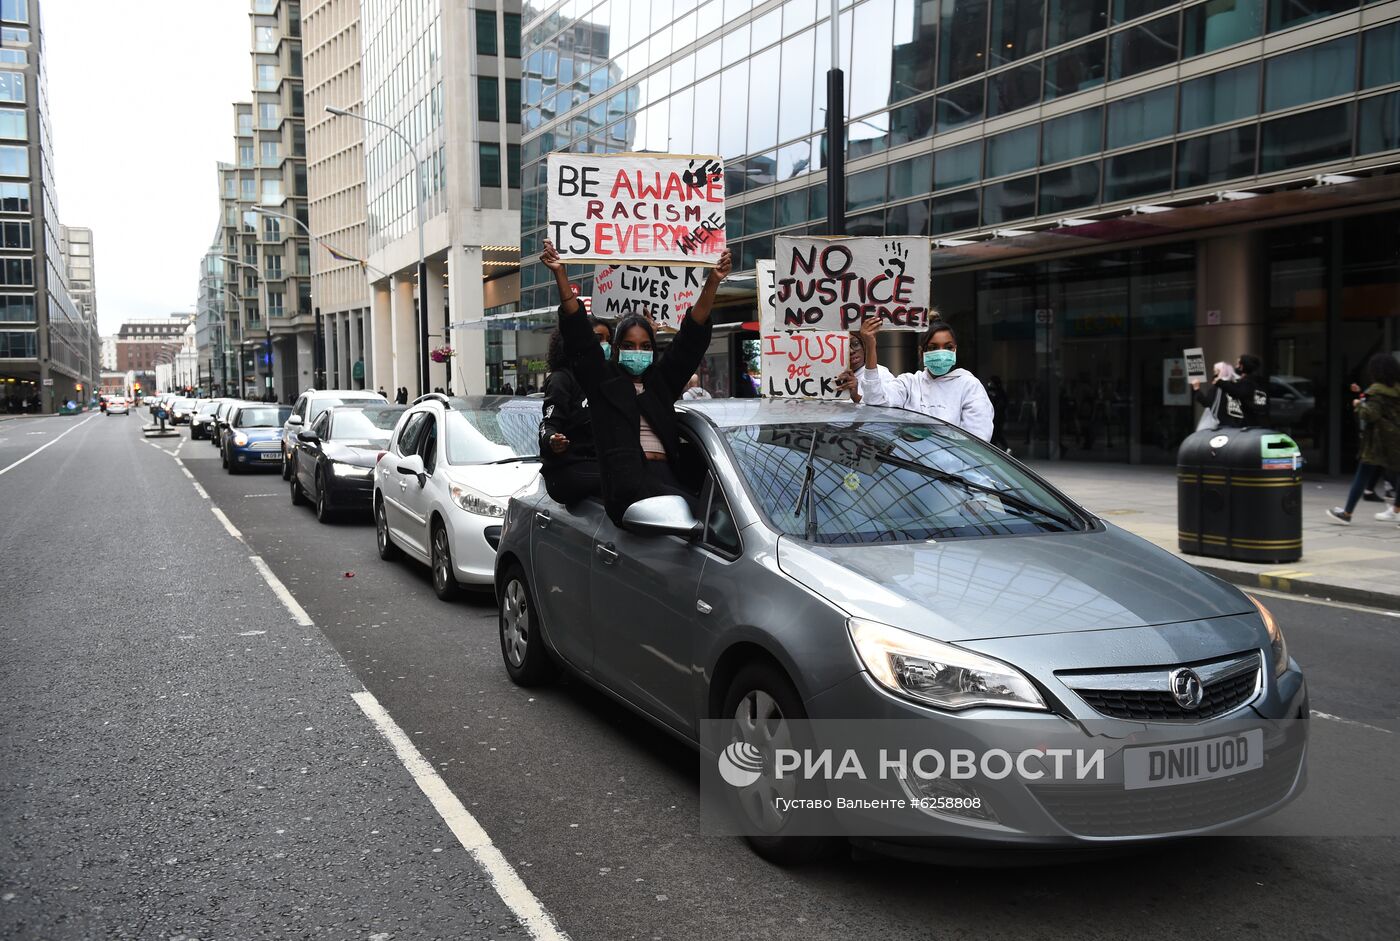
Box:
[529,494,606,674]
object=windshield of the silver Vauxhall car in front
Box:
[725,420,1084,543]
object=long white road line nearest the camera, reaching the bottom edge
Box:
[351,690,568,941]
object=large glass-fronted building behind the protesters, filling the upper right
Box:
[521,0,1400,472]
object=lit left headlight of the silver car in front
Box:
[846,618,1046,709]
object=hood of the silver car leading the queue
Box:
[778,525,1253,641]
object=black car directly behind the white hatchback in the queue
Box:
[291,405,407,522]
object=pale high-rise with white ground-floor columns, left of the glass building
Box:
[316,0,521,395]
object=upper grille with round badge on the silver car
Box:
[1060,651,1261,723]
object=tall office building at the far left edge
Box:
[0,0,99,412]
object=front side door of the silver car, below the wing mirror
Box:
[591,485,710,735]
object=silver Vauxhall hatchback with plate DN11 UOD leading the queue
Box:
[496,399,1308,863]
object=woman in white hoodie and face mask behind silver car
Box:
[858,316,993,441]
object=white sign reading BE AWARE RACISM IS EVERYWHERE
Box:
[545,154,725,266]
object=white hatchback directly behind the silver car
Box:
[374,393,543,601]
